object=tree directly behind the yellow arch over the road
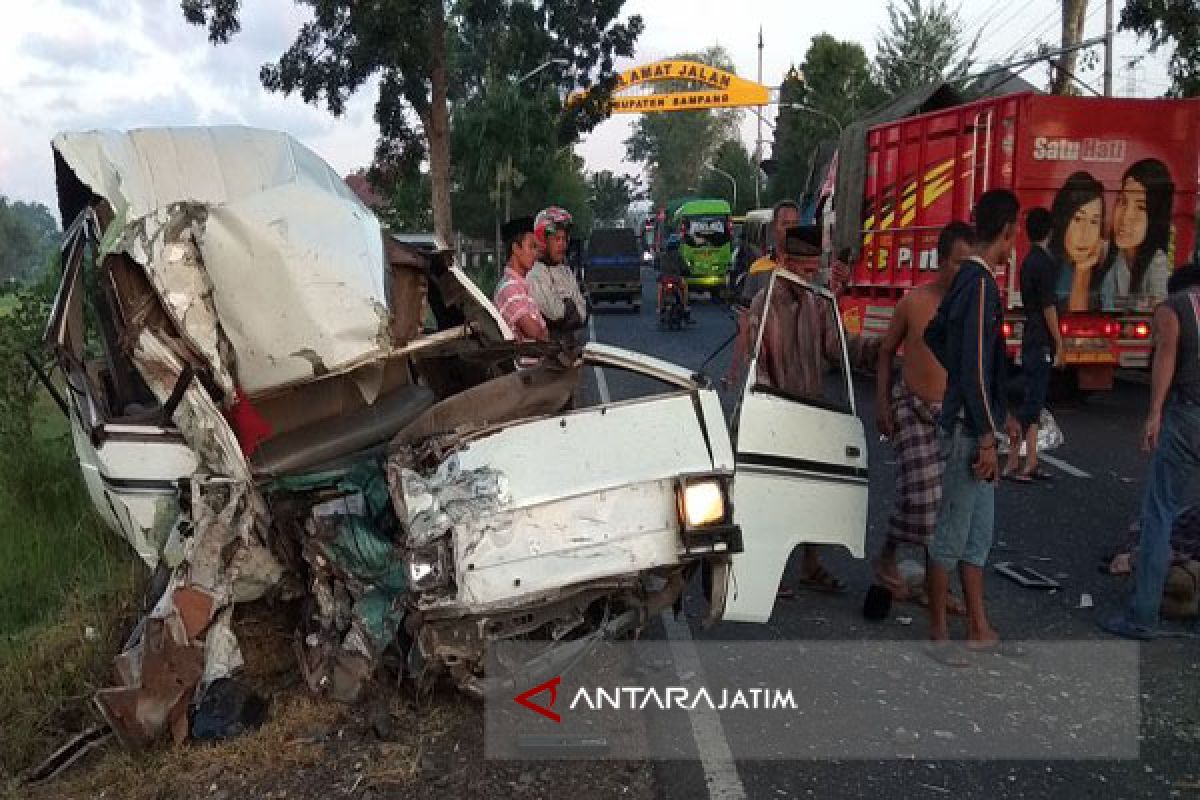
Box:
[625,46,742,206]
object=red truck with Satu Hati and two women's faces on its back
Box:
[821,92,1200,390]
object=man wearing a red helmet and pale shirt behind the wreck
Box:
[528,205,587,338]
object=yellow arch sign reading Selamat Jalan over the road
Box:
[571,59,770,114]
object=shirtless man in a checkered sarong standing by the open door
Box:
[875,222,974,601]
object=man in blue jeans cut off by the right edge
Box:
[1100,261,1200,639]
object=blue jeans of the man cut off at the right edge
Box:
[1129,401,1200,628]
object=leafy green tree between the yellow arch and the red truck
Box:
[767,34,884,206]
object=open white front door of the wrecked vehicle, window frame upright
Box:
[724,270,868,622]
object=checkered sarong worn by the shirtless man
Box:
[888,380,943,547]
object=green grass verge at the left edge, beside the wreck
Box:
[0,398,145,784]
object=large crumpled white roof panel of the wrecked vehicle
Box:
[53,126,389,395]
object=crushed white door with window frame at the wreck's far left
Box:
[43,209,198,567]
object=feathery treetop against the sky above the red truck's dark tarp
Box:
[875,0,982,97]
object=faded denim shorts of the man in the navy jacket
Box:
[929,422,996,572]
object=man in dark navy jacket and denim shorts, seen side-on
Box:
[925,190,1019,666]
